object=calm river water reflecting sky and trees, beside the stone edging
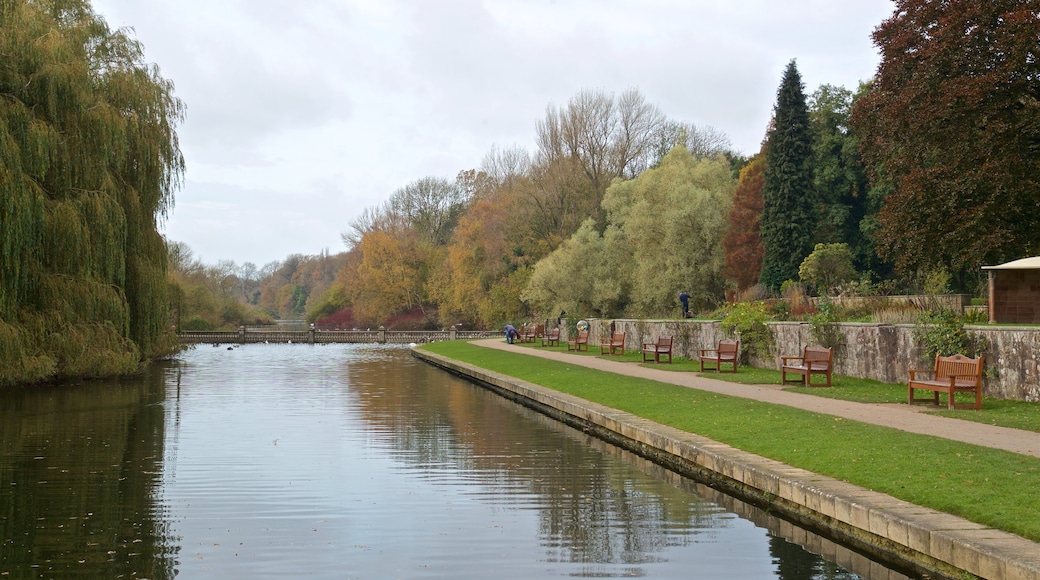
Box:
[0,344,906,580]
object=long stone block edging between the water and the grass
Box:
[412,348,1040,580]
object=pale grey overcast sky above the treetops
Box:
[93,0,893,266]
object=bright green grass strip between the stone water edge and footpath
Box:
[423,341,1040,542]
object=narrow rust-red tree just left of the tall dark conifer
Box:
[723,153,765,291]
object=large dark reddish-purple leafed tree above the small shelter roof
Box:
[853,0,1040,271]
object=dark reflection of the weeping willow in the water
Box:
[0,366,177,580]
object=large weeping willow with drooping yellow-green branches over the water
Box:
[0,0,184,385]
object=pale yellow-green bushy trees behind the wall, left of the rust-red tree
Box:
[522,148,734,316]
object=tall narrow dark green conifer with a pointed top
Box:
[759,60,816,290]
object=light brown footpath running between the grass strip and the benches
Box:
[473,339,1040,457]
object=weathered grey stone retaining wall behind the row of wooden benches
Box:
[589,318,1040,402]
